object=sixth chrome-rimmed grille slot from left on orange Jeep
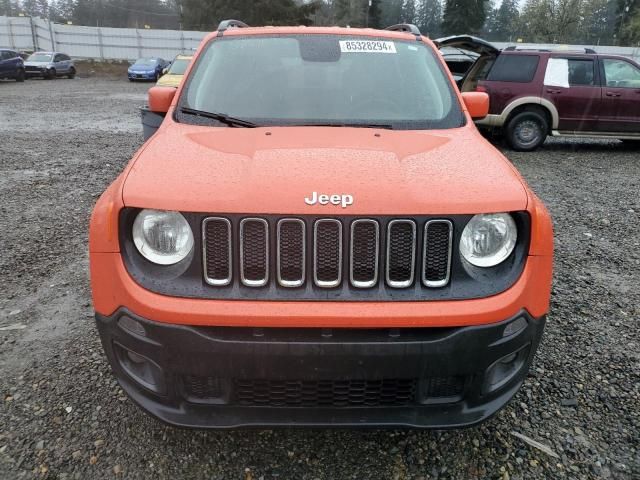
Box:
[386,220,416,288]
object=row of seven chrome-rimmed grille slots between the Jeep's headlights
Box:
[202,216,453,292]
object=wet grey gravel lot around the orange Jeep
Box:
[0,77,640,480]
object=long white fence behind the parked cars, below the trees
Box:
[0,16,640,61]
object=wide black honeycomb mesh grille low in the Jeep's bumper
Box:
[234,379,417,407]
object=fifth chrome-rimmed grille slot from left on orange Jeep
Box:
[350,219,380,288]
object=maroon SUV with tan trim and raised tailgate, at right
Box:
[436,36,640,151]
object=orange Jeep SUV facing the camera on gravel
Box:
[90,20,553,428]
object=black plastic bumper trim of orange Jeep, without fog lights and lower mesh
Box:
[96,309,545,428]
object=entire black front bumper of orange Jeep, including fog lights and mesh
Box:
[96,309,545,428]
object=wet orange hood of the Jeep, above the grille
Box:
[123,124,527,215]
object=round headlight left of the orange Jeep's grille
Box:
[133,210,193,265]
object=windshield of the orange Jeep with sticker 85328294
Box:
[176,35,464,129]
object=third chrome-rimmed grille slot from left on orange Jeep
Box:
[277,218,307,287]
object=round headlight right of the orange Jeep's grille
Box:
[460,213,518,267]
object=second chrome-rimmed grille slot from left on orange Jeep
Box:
[240,218,269,287]
